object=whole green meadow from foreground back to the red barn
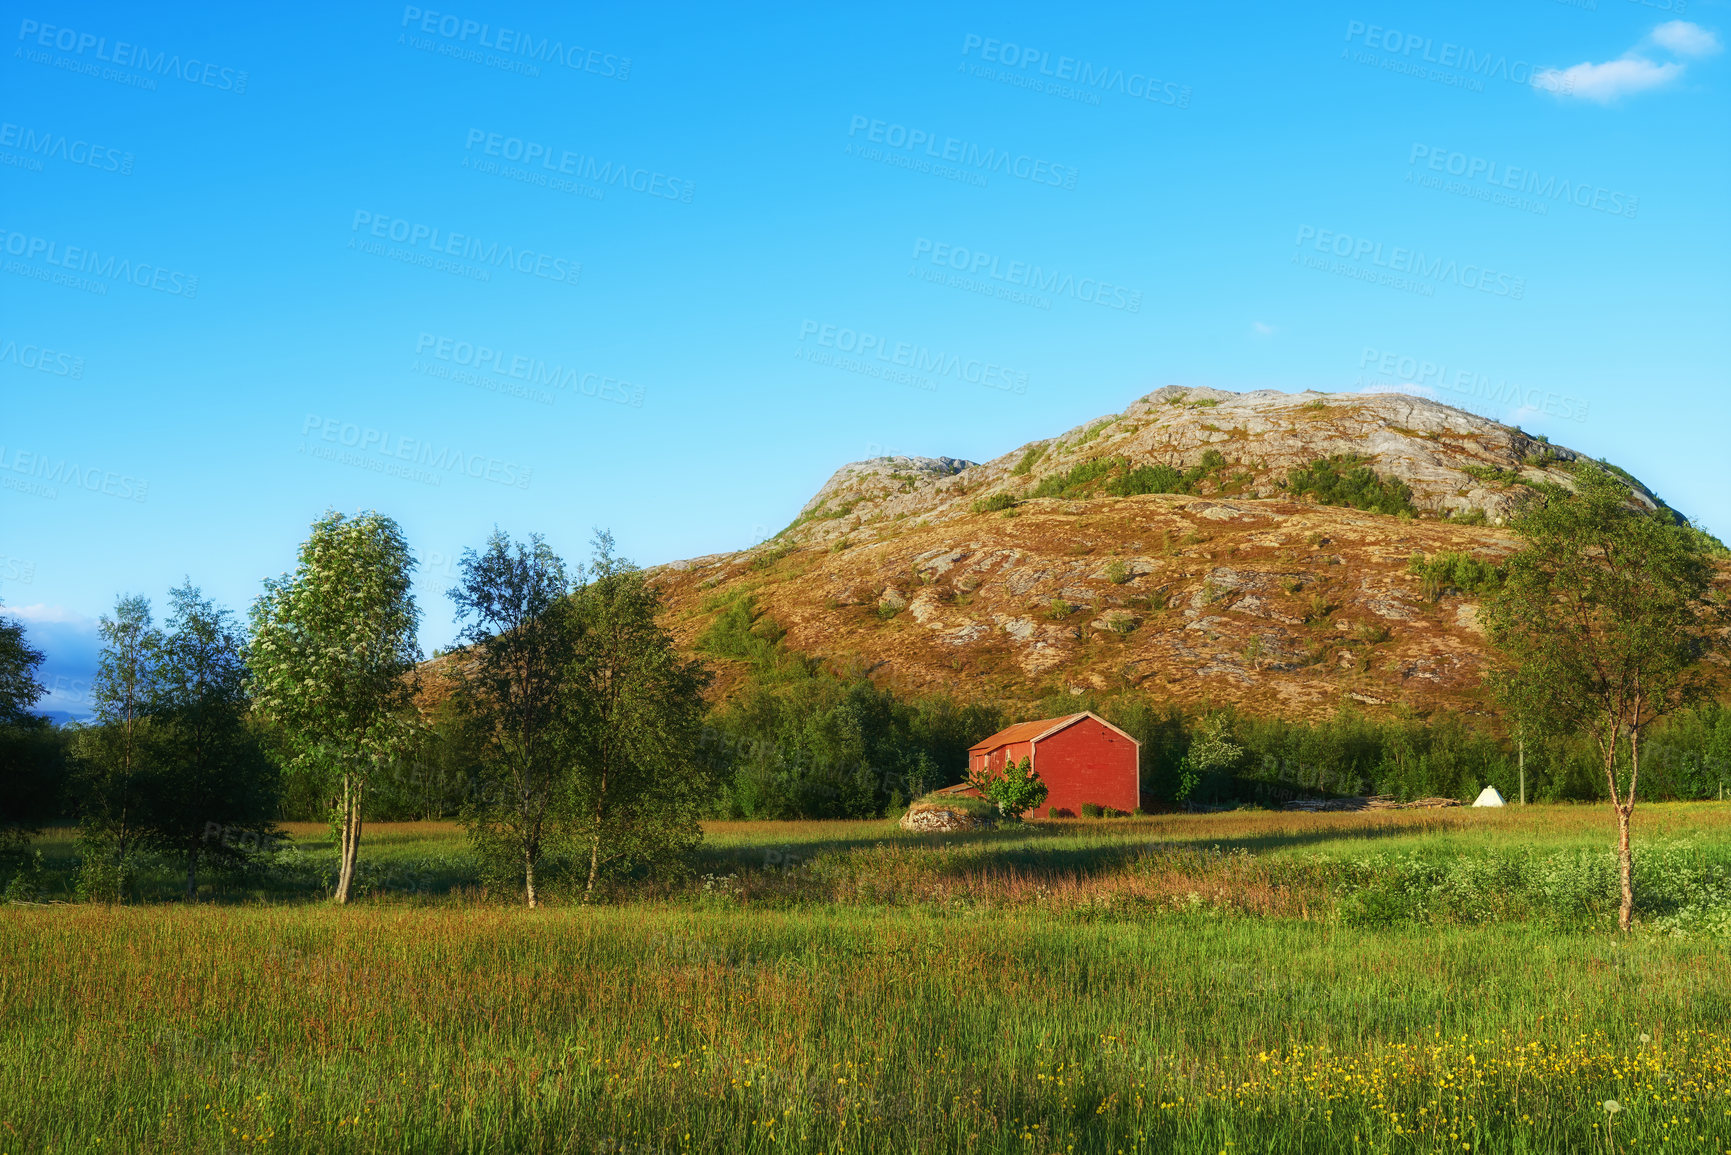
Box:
[0,805,1731,1155]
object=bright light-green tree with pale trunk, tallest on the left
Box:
[248,511,421,904]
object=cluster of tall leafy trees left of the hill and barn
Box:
[0,513,710,906]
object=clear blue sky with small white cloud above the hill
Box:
[0,0,1731,713]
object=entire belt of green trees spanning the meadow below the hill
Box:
[0,462,1731,919]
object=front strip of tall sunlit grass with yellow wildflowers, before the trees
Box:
[0,900,1731,1152]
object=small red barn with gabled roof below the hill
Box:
[968,712,1142,817]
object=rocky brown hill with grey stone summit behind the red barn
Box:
[654,388,1689,717]
